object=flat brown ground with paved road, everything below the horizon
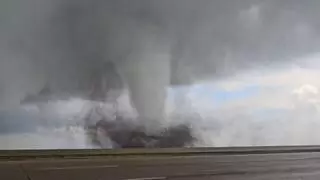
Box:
[0,147,320,180]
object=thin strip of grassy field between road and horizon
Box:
[0,146,320,161]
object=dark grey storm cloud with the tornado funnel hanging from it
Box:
[0,0,320,148]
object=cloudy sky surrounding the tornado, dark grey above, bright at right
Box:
[0,0,320,148]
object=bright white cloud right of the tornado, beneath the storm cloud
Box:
[180,54,320,146]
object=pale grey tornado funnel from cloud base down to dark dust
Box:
[120,51,171,133]
